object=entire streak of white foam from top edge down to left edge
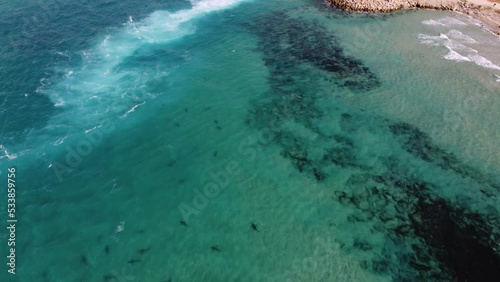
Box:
[4,0,249,162]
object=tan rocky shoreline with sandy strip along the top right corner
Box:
[325,0,500,35]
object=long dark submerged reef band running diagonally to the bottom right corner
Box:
[246,10,500,281]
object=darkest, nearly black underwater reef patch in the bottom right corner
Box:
[412,195,500,281]
